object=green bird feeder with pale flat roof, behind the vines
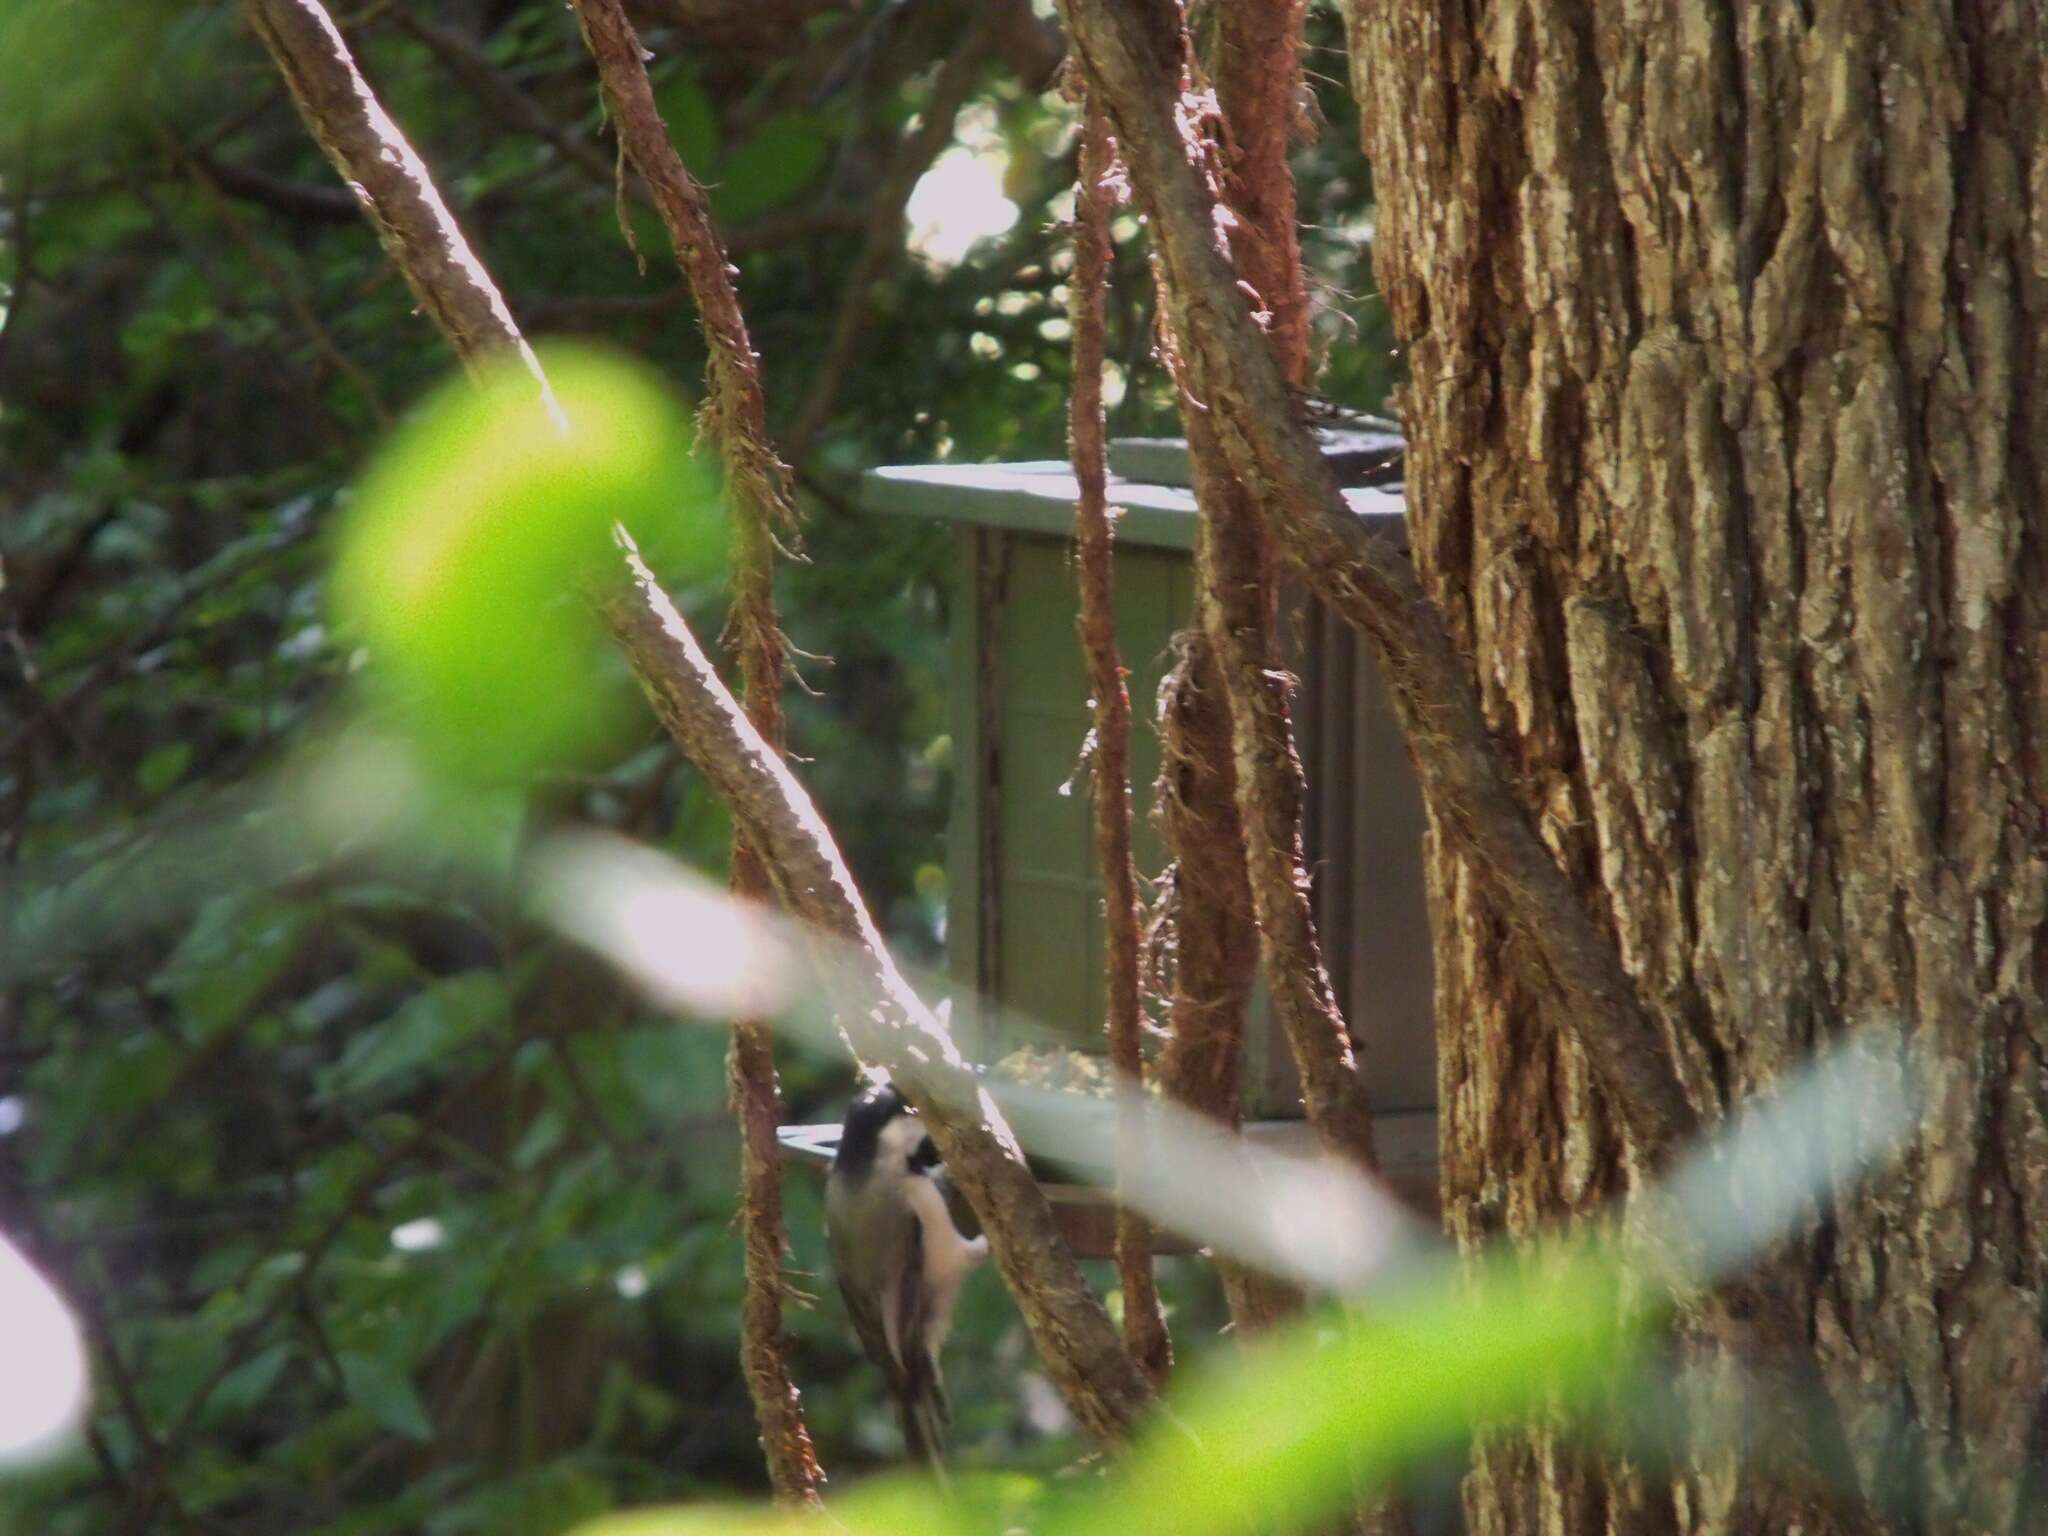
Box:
[782,424,1436,1257]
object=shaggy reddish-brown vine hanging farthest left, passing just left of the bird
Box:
[575,0,825,1505]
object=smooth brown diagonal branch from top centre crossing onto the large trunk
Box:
[1061,0,1698,1163]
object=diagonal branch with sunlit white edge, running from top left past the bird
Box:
[248,0,1151,1444]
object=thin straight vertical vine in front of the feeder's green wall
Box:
[1067,99,1174,1382]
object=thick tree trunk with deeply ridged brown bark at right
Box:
[1350,0,2048,1532]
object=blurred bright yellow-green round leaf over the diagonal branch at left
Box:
[332,346,725,782]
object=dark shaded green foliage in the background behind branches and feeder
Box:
[0,0,1384,1536]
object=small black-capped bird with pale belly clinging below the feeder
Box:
[825,1083,989,1466]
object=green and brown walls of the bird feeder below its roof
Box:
[948,514,1436,1116]
